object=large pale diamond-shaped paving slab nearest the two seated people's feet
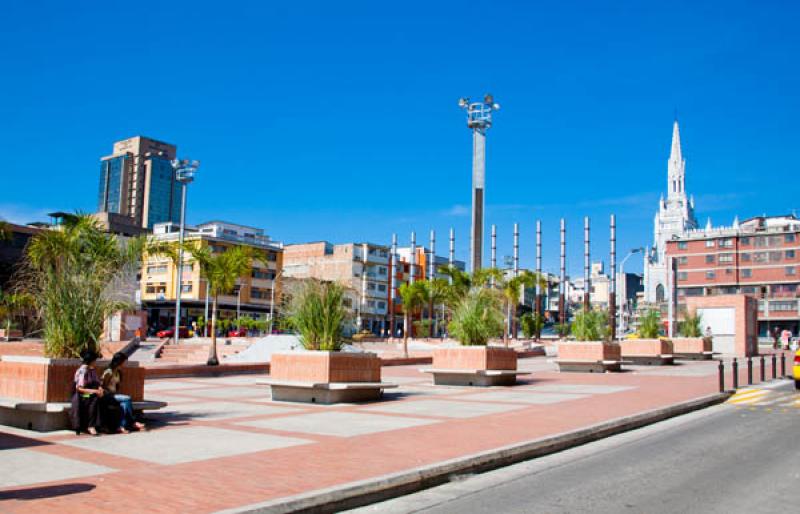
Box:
[62,427,312,465]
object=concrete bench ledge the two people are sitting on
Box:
[0,398,167,432]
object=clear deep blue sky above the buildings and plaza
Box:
[0,0,800,272]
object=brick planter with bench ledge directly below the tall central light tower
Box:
[423,346,527,386]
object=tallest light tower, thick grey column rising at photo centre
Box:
[458,94,500,273]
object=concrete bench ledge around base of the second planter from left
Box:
[256,379,397,404]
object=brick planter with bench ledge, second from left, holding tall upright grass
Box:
[266,351,397,403]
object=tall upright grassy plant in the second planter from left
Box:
[288,279,348,351]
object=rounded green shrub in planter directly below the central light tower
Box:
[448,288,504,346]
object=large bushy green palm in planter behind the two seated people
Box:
[18,213,144,357]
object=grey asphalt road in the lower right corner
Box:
[353,382,800,514]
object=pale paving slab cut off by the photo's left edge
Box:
[0,446,115,486]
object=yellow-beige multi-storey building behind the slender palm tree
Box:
[140,221,283,331]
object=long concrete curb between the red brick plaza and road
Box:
[218,392,731,514]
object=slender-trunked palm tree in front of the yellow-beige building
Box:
[185,245,256,366]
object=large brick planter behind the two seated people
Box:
[0,355,145,431]
